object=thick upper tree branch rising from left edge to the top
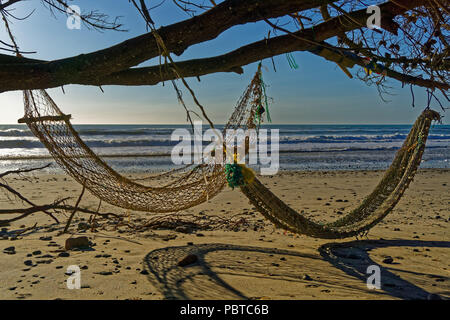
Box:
[0,0,342,92]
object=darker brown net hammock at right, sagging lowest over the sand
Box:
[241,110,440,239]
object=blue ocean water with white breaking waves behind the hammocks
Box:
[0,125,450,172]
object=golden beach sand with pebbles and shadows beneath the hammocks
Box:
[0,170,450,299]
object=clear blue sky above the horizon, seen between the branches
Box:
[0,0,448,124]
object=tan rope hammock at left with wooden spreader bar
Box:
[15,66,263,213]
